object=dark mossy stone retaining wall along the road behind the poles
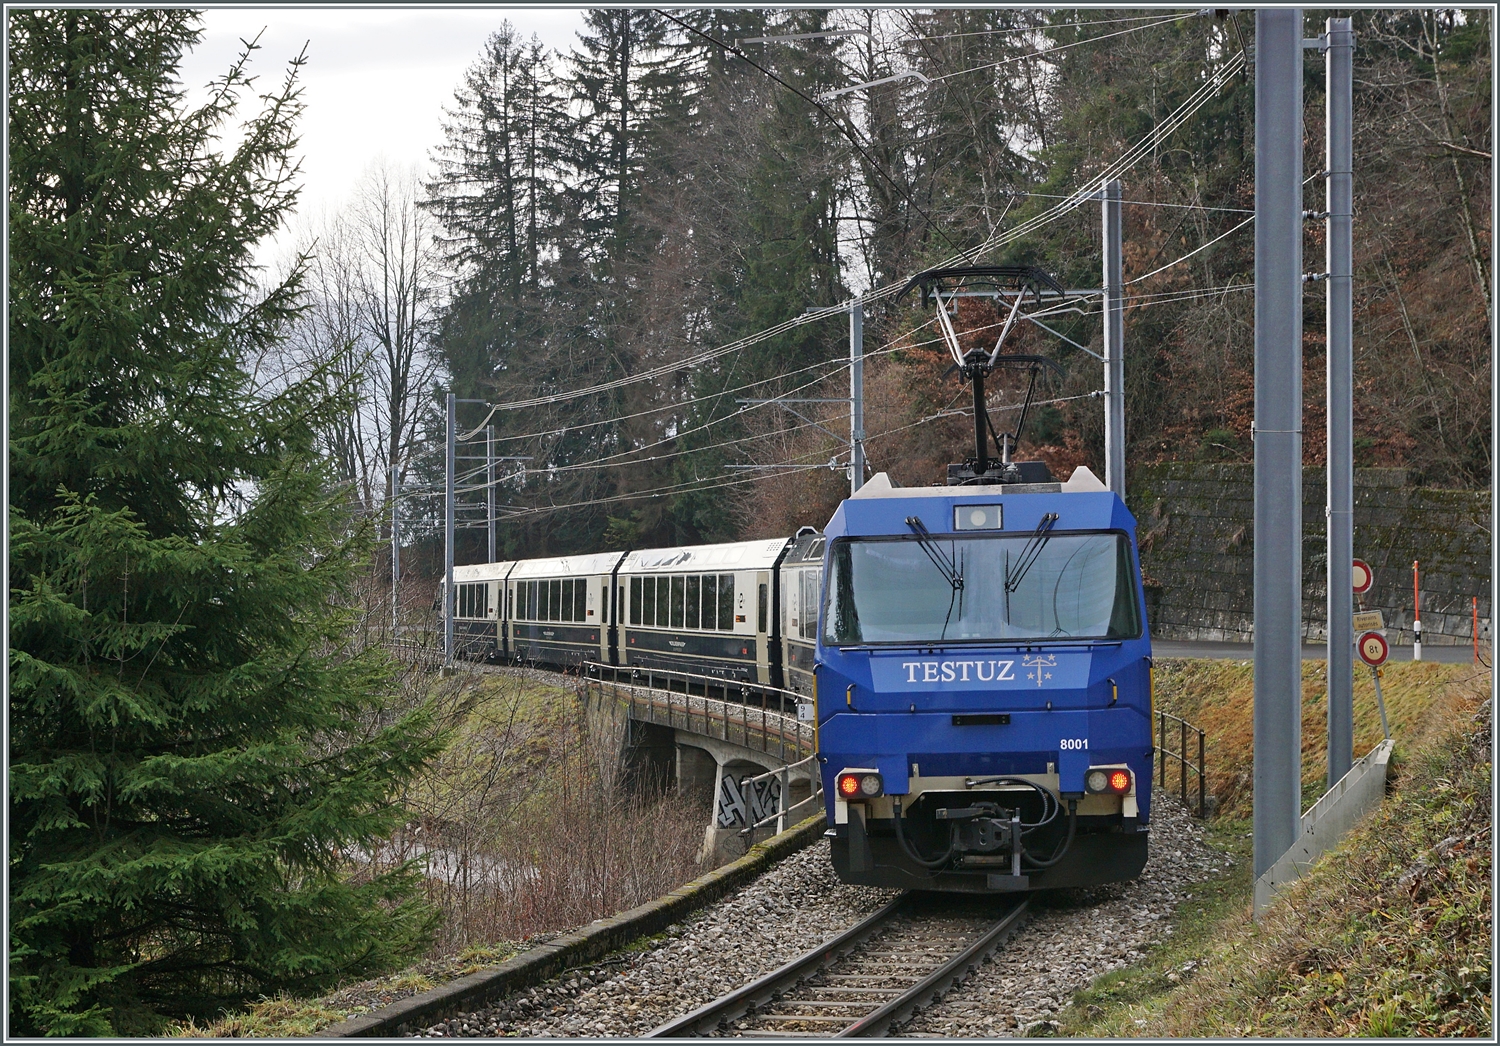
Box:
[1128,462,1490,645]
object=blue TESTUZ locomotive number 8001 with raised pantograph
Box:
[815,266,1154,893]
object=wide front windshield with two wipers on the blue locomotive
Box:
[824,531,1142,645]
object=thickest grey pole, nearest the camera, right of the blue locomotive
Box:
[1254,8,1302,876]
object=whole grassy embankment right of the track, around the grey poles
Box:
[1059,660,1493,1038]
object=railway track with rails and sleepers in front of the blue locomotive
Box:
[648,893,1026,1038]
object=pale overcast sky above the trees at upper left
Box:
[180,6,582,260]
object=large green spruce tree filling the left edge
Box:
[8,9,437,1034]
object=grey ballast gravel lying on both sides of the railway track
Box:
[413,794,1230,1038]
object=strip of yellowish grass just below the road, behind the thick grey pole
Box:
[1157,659,1490,818]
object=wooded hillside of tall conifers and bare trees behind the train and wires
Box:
[270,8,1493,563]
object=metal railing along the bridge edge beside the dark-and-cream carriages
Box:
[582,662,816,762]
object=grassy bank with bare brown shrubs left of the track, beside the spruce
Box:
[179,671,708,1037]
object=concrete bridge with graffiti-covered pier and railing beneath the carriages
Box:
[579,662,822,861]
